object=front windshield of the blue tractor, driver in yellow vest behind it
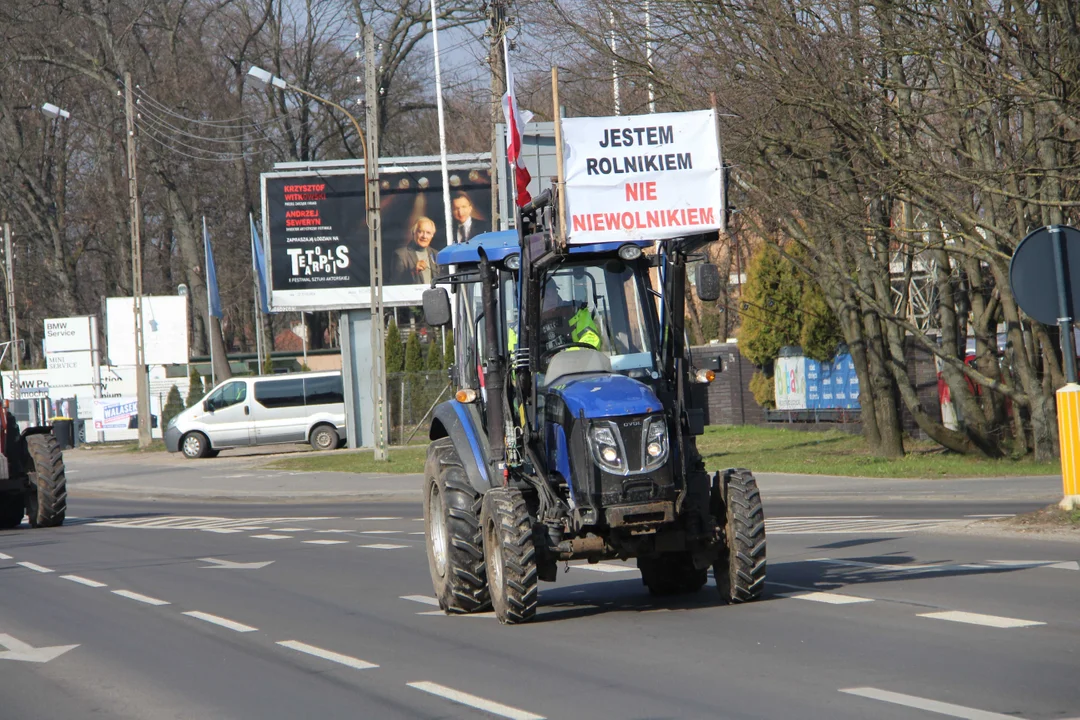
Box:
[540,259,654,375]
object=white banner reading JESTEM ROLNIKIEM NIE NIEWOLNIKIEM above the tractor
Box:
[563,110,724,245]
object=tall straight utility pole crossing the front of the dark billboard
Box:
[364,25,390,460]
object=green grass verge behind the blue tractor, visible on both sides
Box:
[268,426,1061,478]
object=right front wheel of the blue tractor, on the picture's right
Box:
[713,467,766,603]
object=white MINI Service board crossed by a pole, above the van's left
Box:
[105,295,188,365]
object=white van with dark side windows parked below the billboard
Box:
[165,371,346,458]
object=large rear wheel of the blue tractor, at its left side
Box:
[423,437,491,613]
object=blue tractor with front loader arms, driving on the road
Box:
[423,192,766,624]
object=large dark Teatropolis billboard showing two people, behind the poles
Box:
[261,164,491,312]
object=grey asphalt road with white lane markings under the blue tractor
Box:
[0,459,1080,720]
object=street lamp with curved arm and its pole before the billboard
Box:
[247,60,389,460]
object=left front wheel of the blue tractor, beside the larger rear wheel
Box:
[481,488,540,625]
